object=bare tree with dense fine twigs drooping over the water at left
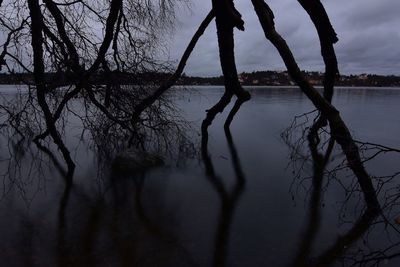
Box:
[0,0,206,183]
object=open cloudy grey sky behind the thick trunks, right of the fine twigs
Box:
[169,0,400,76]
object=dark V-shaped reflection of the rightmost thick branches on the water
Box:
[287,116,400,267]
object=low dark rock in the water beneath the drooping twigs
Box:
[112,150,164,172]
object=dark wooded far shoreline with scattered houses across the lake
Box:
[0,71,400,87]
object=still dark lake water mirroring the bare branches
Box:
[0,87,400,267]
